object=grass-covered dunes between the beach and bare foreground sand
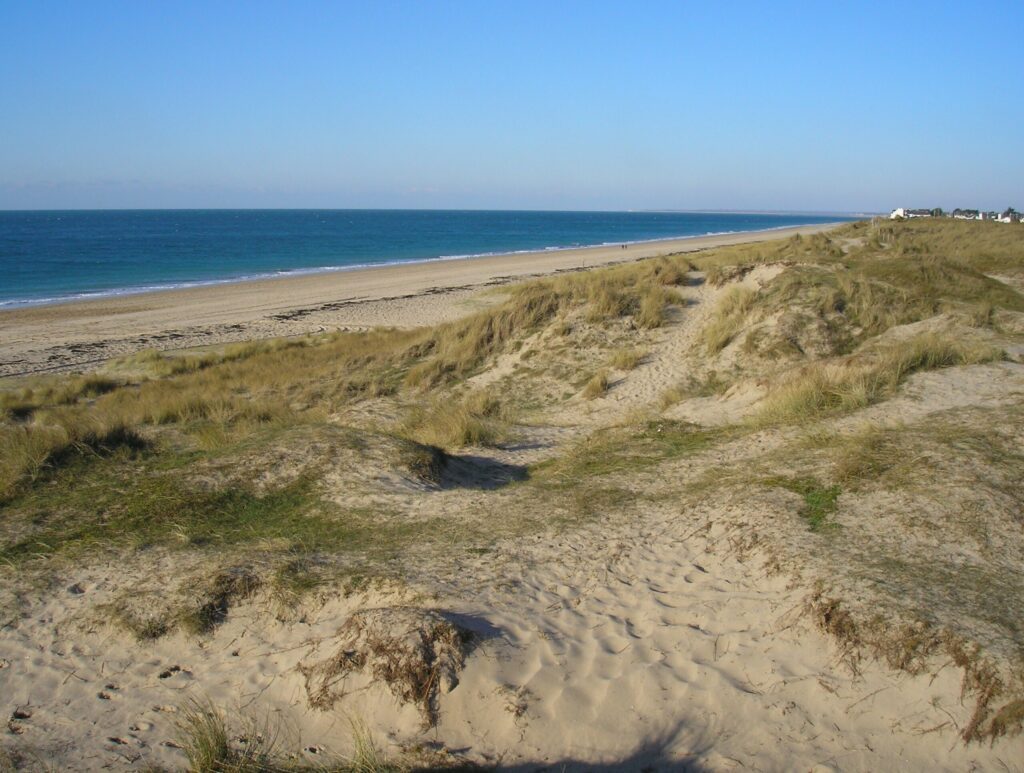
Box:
[0,216,1024,761]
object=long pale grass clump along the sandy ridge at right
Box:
[755,333,1005,425]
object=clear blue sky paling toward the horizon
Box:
[0,0,1024,212]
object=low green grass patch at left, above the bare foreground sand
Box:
[0,433,448,565]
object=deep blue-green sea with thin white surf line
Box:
[0,209,853,308]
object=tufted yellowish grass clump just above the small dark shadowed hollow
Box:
[400,390,513,449]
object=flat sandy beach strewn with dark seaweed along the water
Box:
[0,223,840,377]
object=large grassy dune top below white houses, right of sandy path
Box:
[693,220,1024,364]
